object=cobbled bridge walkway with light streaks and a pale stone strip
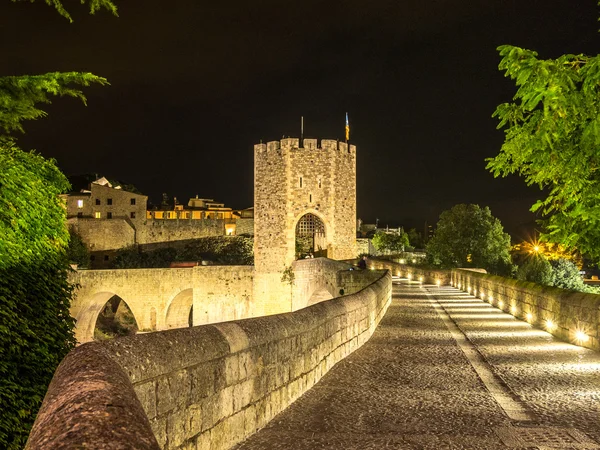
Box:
[236,280,600,450]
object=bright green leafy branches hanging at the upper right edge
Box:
[487,45,600,260]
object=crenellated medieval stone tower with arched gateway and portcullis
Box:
[254,138,356,314]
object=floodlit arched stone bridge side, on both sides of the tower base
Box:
[71,258,370,343]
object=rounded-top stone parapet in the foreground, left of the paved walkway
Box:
[26,271,392,449]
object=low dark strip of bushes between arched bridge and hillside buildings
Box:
[113,236,254,269]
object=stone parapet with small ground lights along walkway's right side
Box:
[452,269,600,350]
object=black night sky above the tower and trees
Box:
[0,0,600,239]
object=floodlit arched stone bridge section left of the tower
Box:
[70,266,255,342]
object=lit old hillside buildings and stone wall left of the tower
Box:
[63,178,254,268]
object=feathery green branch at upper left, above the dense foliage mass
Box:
[0,72,108,135]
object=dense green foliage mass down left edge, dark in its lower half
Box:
[0,142,75,449]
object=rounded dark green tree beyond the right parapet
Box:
[426,204,512,275]
